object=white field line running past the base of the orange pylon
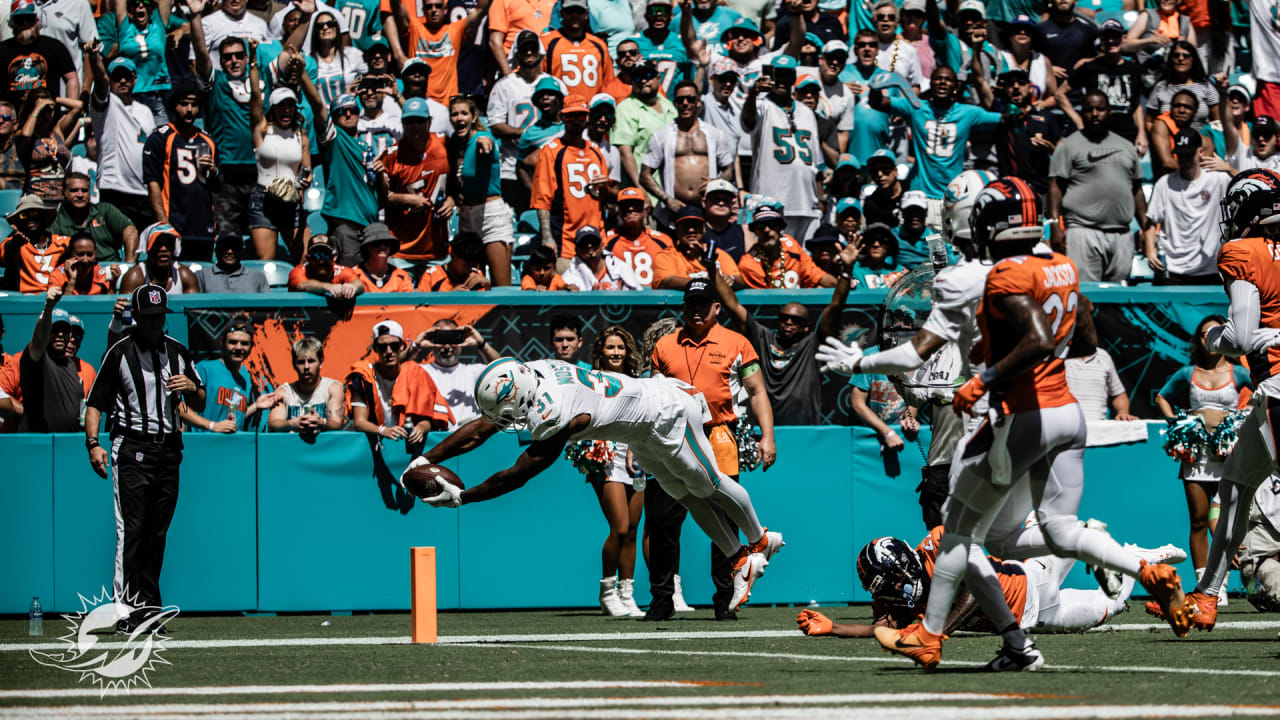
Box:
[0,620,1280,652]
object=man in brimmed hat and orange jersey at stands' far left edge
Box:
[0,195,70,295]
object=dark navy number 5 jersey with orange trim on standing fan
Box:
[142,123,220,237]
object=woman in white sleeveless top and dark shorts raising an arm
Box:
[248,40,311,260]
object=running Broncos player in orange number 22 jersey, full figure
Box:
[876,178,1189,671]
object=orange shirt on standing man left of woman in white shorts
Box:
[380,137,449,261]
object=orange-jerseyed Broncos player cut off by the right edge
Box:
[1148,168,1280,630]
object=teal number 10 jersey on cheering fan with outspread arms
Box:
[890,96,1000,200]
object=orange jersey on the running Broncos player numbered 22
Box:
[978,252,1080,413]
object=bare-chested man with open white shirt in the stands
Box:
[640,81,735,222]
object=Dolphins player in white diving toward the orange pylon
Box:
[401,357,783,610]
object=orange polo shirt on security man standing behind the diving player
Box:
[653,320,760,425]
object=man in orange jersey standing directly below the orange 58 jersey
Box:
[529,95,612,260]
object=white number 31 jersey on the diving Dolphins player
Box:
[525,360,701,445]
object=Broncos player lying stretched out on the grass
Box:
[796,527,1187,638]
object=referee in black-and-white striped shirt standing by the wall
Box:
[84,284,204,634]
